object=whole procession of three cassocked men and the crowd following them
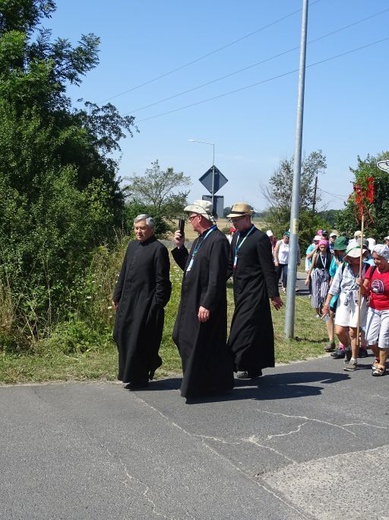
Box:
[113,200,389,402]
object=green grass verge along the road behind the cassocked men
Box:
[0,263,328,384]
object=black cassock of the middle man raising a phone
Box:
[172,228,234,398]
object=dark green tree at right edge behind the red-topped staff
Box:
[336,152,389,242]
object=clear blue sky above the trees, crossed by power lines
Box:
[44,0,389,210]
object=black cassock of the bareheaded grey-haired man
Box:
[113,236,171,384]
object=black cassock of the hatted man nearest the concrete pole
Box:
[228,227,279,375]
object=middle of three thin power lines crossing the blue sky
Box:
[126,8,389,115]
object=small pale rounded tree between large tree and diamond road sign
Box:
[125,160,191,220]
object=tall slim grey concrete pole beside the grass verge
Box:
[285,0,308,338]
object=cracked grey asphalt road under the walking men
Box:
[0,356,389,520]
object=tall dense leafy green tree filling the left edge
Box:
[0,0,134,344]
